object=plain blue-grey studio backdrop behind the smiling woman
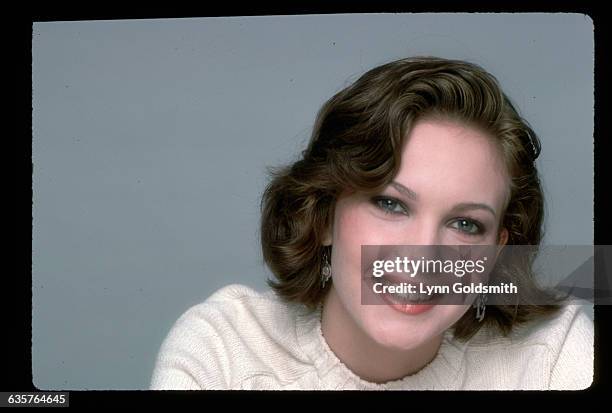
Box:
[32,14,593,390]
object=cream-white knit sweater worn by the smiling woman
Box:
[150,284,593,390]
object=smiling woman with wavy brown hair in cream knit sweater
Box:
[151,57,593,390]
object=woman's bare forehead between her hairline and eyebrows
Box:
[396,120,509,209]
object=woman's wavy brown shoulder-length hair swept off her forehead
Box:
[260,57,558,339]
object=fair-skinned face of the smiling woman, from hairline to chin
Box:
[326,120,509,350]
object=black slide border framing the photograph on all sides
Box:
[7,1,612,408]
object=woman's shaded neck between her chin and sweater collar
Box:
[321,286,442,383]
